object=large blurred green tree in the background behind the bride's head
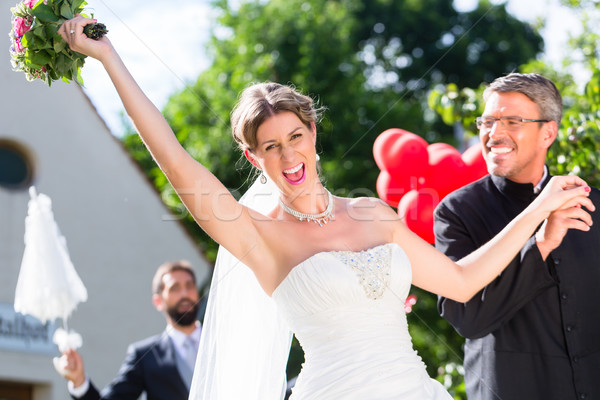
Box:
[124,0,543,394]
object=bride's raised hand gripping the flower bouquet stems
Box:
[58,15,113,61]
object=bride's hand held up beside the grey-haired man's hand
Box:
[532,175,596,219]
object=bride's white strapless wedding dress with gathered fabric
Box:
[272,243,452,400]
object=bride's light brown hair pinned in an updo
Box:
[231,82,322,151]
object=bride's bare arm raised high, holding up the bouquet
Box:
[59,16,264,265]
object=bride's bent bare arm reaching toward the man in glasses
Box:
[394,176,595,303]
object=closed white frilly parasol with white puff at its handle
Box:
[14,186,87,366]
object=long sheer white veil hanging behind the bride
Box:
[189,179,292,400]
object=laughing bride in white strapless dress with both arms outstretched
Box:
[59,16,594,400]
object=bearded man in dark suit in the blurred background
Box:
[56,260,201,400]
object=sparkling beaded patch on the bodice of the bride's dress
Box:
[332,242,392,300]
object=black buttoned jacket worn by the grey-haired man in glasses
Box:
[435,175,600,400]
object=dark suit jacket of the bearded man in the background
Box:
[73,333,189,400]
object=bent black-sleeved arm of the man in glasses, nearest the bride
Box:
[434,202,555,339]
